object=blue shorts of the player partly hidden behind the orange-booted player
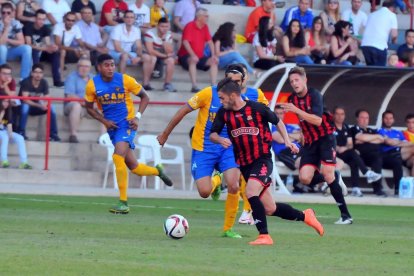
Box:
[191,147,239,180]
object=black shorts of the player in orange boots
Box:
[240,157,273,188]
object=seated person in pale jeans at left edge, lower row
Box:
[0,99,32,170]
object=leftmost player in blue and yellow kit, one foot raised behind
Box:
[85,54,173,214]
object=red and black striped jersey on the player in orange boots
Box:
[211,101,279,166]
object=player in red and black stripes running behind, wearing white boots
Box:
[282,67,353,224]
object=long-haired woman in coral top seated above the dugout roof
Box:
[305,16,329,64]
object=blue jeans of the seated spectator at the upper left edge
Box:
[0,45,32,80]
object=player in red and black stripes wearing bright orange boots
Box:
[210,78,324,245]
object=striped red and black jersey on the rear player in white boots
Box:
[288,88,335,144]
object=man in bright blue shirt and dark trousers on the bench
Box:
[378,110,414,195]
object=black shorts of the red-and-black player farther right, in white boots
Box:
[299,134,336,169]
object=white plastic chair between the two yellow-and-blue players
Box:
[137,135,185,190]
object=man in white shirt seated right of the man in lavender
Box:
[108,10,142,74]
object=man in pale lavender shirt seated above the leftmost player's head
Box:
[76,6,109,65]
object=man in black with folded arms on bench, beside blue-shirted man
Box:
[350,109,387,197]
